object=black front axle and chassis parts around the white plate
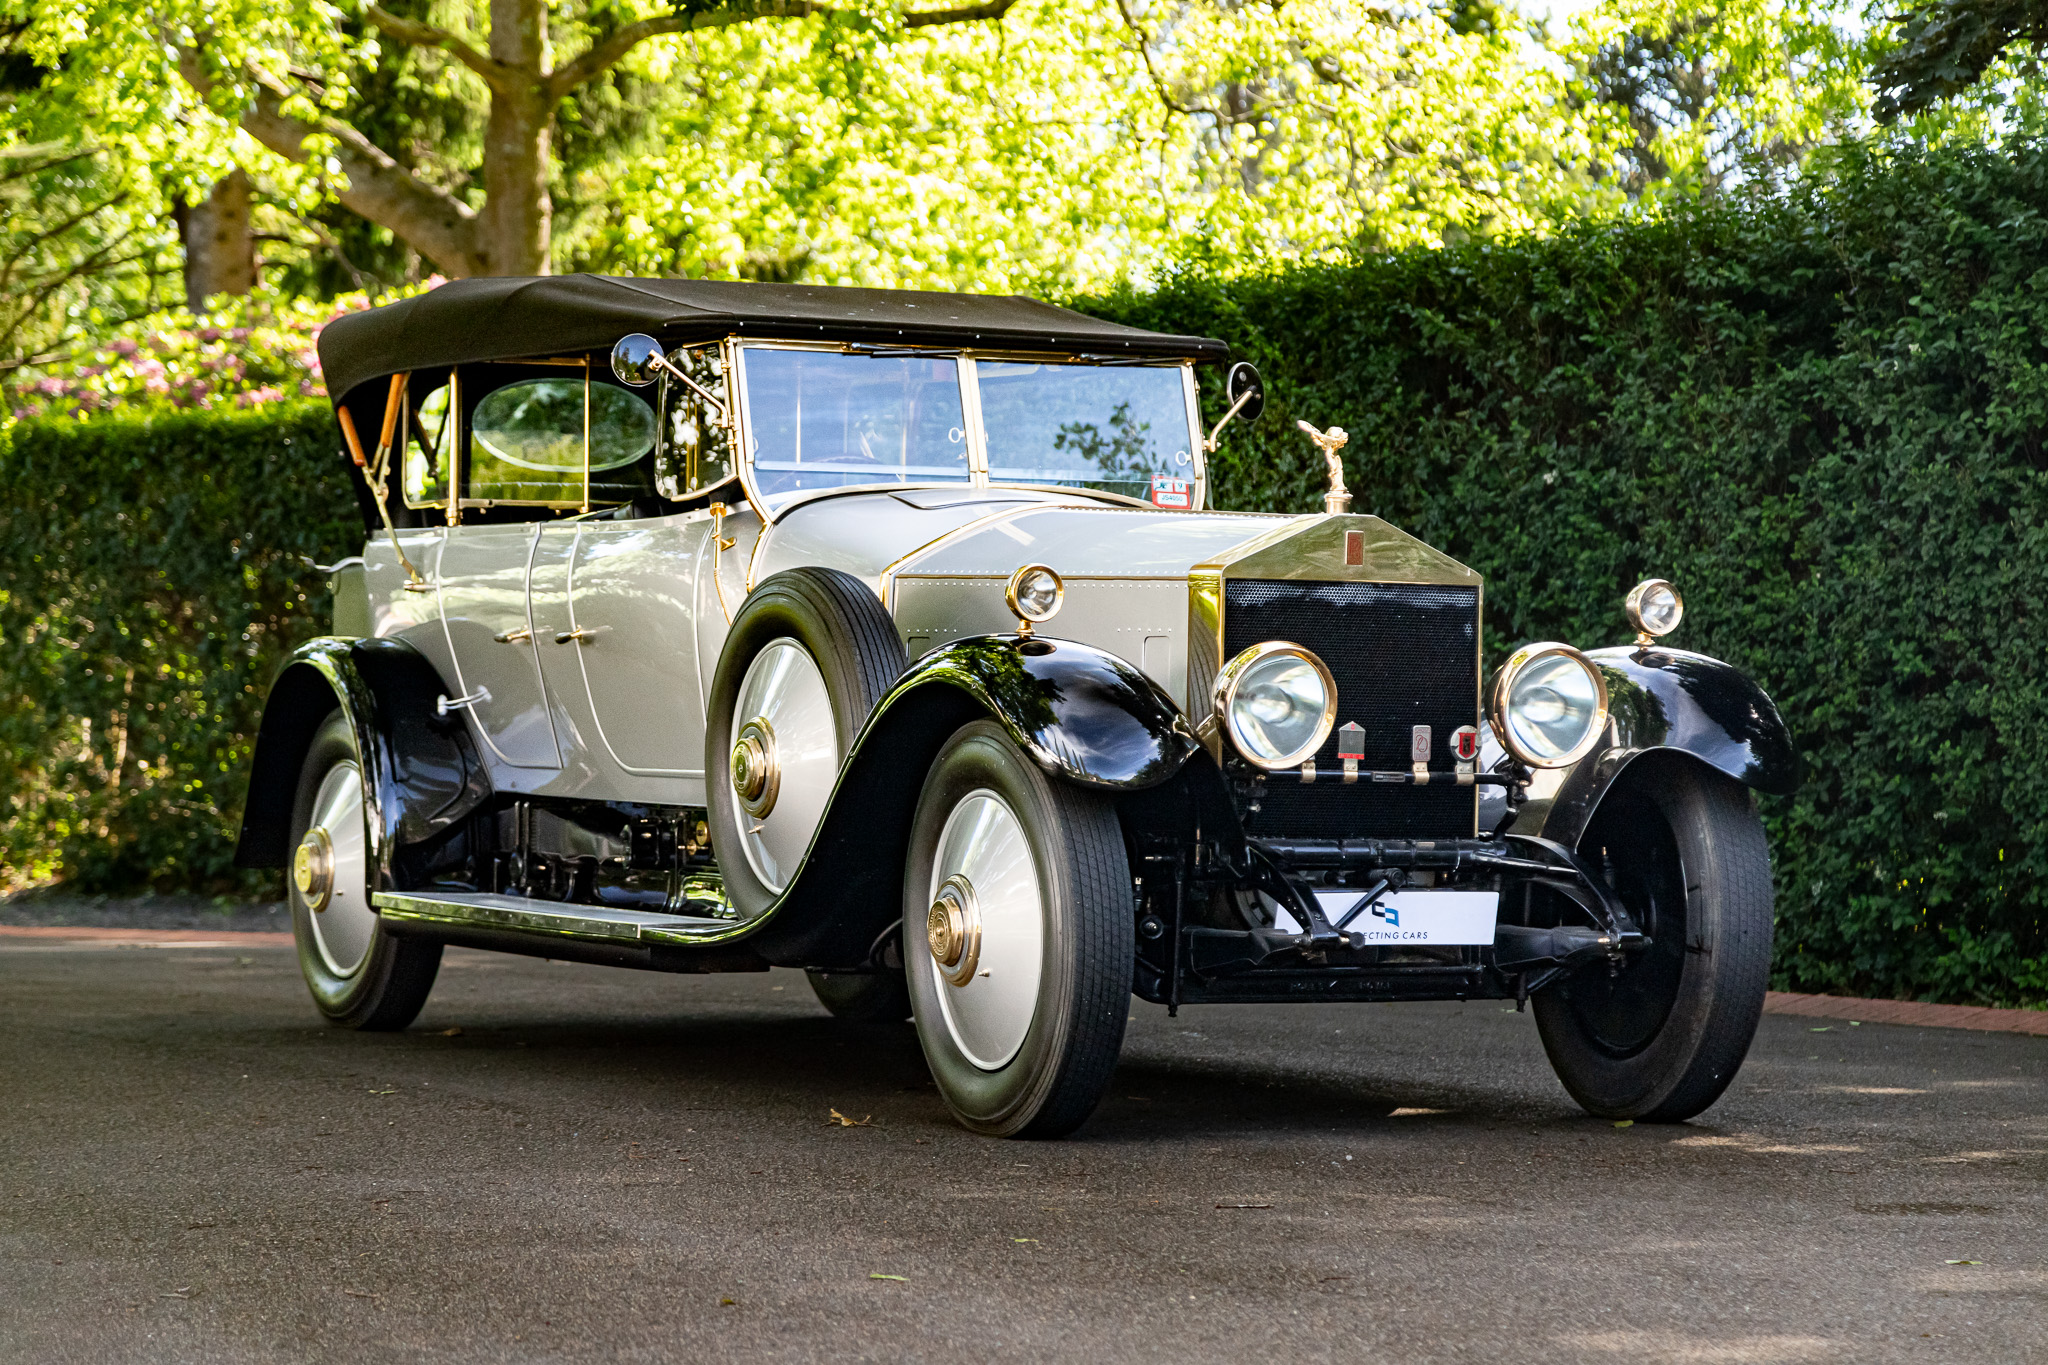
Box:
[1133,835,1649,1011]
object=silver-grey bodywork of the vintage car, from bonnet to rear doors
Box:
[362,487,1315,806]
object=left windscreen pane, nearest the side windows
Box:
[743,346,971,503]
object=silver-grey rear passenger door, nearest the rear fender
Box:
[438,522,561,769]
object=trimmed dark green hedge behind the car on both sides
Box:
[12,141,2048,1003]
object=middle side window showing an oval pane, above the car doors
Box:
[467,375,655,508]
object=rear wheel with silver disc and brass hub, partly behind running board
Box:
[285,710,440,1031]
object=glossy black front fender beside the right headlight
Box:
[1511,645,1798,847]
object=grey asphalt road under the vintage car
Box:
[0,945,2048,1365]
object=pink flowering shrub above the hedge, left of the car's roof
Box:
[0,276,442,420]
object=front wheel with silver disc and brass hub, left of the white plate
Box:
[903,720,1135,1138]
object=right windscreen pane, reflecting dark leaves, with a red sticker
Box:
[975,360,1194,508]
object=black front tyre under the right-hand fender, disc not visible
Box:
[1534,757,1772,1124]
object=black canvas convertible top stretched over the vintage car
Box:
[319,274,1229,401]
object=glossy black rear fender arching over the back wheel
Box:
[236,636,489,888]
